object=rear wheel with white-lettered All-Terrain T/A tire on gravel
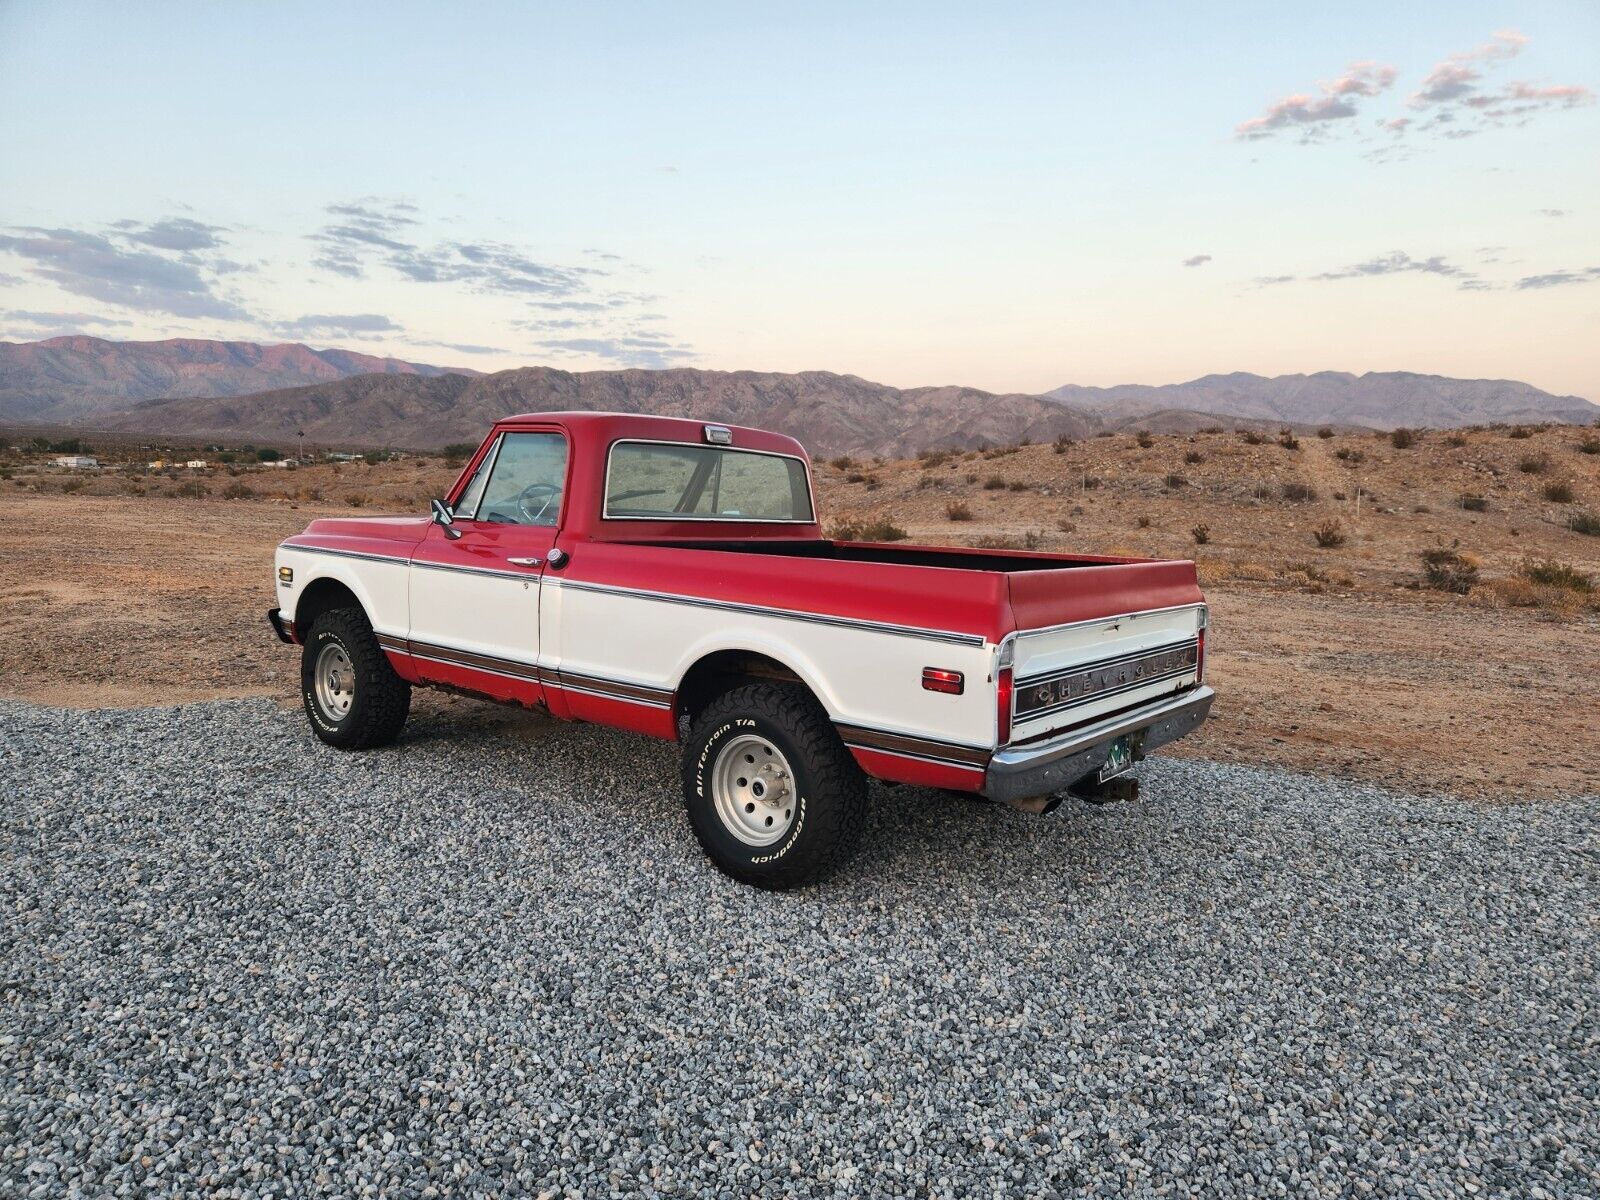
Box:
[683,683,867,891]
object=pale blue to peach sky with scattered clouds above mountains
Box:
[0,0,1600,400]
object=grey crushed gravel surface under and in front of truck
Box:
[0,701,1600,1197]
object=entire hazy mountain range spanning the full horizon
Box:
[0,338,1600,456]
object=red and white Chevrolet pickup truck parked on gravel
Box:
[270,413,1213,888]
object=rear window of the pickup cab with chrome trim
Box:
[605,442,813,522]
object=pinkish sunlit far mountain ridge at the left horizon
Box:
[0,338,477,424]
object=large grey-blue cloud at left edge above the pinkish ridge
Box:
[0,226,250,322]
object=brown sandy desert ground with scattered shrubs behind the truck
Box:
[0,427,1600,802]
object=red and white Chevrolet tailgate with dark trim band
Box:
[1011,562,1206,746]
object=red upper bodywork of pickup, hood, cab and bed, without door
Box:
[291,413,1202,642]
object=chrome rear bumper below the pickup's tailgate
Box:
[984,686,1216,800]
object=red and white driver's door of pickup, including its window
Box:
[408,430,568,704]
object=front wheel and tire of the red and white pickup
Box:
[301,608,411,750]
